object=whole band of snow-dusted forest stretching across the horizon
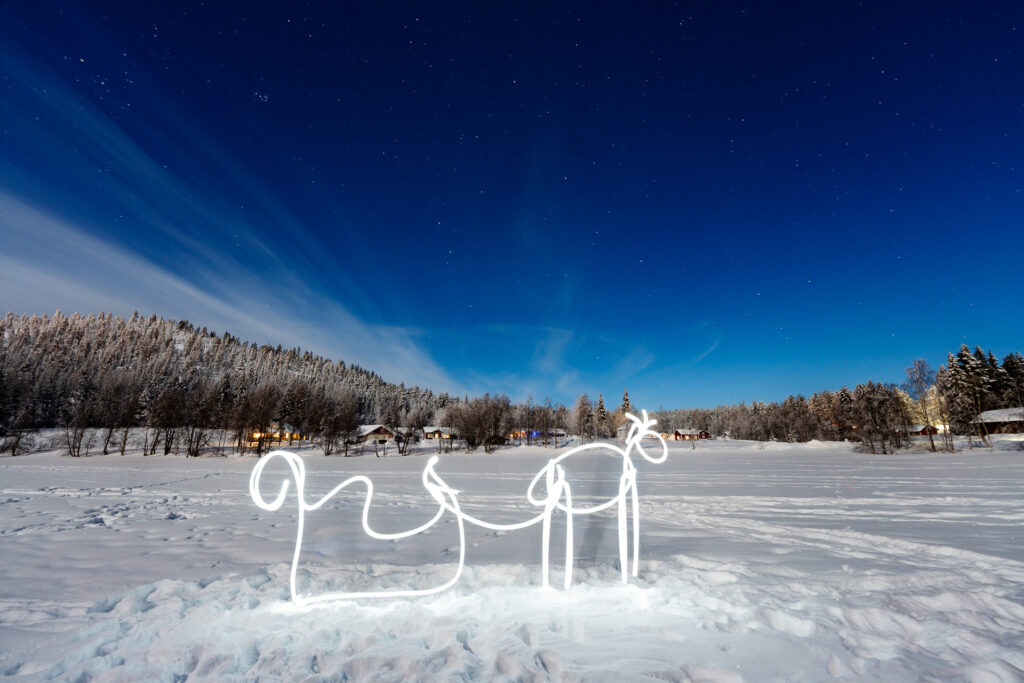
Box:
[0,311,1024,456]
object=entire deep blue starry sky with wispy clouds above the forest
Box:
[0,2,1024,408]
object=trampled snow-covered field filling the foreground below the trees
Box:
[0,441,1024,681]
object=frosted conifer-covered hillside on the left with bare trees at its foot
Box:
[0,311,458,455]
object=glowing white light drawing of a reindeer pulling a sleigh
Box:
[249,411,669,606]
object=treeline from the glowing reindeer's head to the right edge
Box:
[655,345,1024,453]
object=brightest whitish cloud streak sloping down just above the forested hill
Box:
[0,191,460,391]
